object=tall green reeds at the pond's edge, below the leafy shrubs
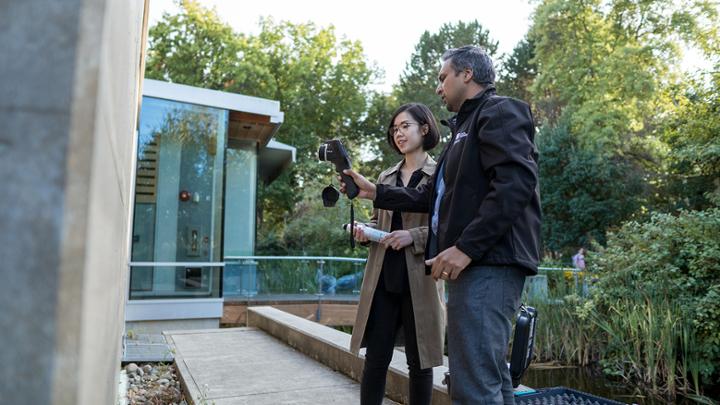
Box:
[525,273,712,403]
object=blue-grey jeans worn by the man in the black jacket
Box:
[447,266,526,405]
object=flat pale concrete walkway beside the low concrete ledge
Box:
[165,328,397,405]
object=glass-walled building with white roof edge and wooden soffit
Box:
[126,80,295,326]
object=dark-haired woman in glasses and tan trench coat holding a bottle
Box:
[350,104,445,405]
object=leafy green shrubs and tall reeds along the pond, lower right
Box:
[529,208,720,403]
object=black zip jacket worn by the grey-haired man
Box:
[374,87,540,274]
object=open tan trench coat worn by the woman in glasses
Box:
[350,156,445,369]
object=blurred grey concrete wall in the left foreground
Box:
[0,0,147,404]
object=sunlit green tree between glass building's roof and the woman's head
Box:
[236,19,375,233]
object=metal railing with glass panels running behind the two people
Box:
[129,256,588,301]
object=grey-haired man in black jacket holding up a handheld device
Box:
[346,46,540,405]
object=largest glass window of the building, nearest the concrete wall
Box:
[130,97,225,299]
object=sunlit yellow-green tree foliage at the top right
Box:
[530,0,717,152]
